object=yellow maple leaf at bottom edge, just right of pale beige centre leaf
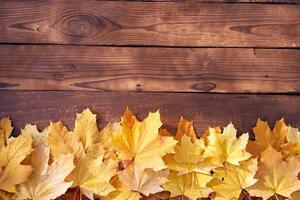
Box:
[163,170,213,200]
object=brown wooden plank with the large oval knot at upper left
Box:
[0,0,300,48]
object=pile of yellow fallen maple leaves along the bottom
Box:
[0,109,300,200]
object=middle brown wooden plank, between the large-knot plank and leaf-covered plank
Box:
[0,45,300,93]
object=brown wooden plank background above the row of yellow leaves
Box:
[0,0,300,139]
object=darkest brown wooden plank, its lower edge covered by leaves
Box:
[0,91,300,137]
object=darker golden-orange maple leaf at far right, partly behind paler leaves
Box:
[246,119,287,156]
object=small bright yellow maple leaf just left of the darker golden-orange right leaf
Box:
[204,123,251,165]
